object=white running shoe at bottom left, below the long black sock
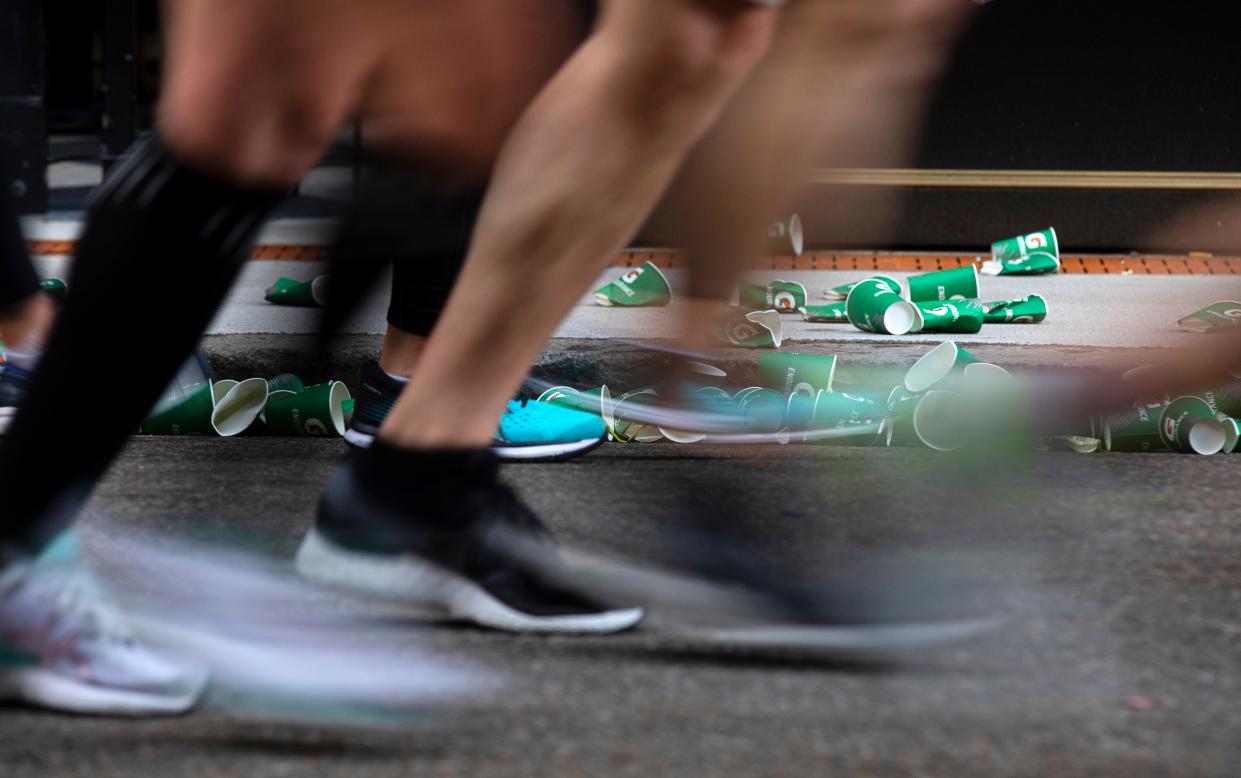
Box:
[0,532,207,716]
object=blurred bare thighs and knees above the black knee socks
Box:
[160,0,582,185]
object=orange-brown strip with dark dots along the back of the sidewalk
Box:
[27,241,1241,275]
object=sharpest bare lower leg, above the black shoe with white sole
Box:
[380,0,778,448]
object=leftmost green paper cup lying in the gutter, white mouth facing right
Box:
[141,378,268,438]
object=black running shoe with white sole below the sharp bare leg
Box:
[297,449,643,634]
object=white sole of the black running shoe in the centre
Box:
[297,530,644,634]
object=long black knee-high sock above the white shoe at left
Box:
[0,136,283,550]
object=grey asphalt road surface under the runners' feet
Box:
[0,438,1241,777]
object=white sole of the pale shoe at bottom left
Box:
[0,668,206,717]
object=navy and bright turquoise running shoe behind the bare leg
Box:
[345,362,607,462]
